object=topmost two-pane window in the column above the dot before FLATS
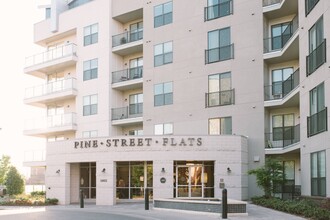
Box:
[154,2,173,28]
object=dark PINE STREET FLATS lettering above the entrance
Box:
[74,137,203,149]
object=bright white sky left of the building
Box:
[0,0,47,172]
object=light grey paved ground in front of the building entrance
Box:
[0,203,304,220]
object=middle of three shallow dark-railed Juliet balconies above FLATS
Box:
[205,44,234,64]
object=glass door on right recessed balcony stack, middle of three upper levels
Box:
[272,67,293,99]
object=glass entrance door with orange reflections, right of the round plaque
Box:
[176,165,204,198]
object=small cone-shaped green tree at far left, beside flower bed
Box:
[5,166,24,195]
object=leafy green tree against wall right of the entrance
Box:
[248,158,285,198]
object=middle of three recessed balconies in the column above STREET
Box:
[112,66,143,90]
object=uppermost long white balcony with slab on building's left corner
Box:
[24,43,77,78]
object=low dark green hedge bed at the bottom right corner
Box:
[252,197,330,220]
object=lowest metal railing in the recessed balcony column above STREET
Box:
[111,103,143,121]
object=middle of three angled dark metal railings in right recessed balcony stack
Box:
[264,69,299,101]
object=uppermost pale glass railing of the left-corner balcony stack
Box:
[25,43,77,67]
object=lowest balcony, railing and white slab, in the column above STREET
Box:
[111,103,143,125]
